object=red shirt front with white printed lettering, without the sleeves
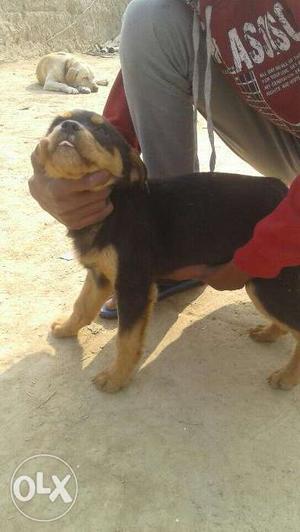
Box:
[200,0,300,137]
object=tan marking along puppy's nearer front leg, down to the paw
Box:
[93,284,157,392]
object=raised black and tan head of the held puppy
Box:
[33,110,146,183]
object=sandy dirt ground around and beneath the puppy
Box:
[0,57,300,532]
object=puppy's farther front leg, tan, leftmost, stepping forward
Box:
[51,272,112,337]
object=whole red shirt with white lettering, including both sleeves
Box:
[103,0,300,278]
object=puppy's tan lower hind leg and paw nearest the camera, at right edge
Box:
[268,329,300,390]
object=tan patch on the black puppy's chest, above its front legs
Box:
[80,245,119,286]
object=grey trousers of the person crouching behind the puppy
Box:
[120,0,300,183]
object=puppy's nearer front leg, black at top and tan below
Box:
[94,284,157,392]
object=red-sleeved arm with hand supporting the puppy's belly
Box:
[168,176,300,290]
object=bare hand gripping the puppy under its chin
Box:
[29,155,113,229]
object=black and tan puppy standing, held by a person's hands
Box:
[34,110,300,392]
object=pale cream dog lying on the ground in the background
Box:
[36,52,108,94]
